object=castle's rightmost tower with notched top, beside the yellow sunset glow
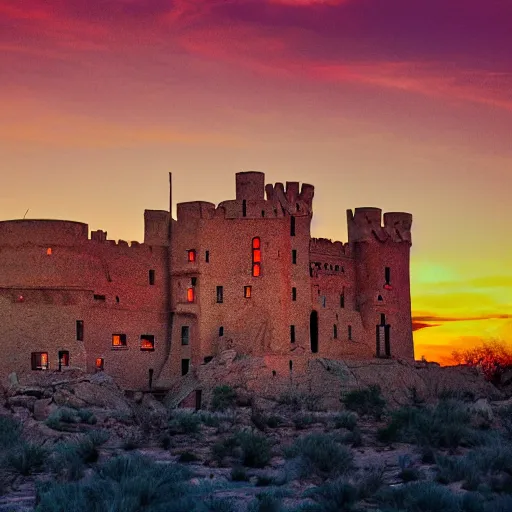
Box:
[347,208,414,359]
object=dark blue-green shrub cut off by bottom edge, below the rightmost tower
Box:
[375,482,460,512]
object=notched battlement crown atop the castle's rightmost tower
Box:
[347,208,412,244]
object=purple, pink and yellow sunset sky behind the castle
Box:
[0,0,512,363]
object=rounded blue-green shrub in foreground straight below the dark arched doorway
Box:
[284,434,354,477]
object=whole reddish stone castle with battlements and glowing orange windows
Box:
[0,172,414,389]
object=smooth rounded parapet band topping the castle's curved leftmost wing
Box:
[0,219,89,246]
